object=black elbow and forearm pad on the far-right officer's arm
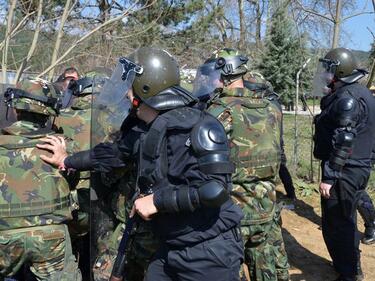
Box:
[329,131,354,172]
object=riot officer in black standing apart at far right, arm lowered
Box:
[314,48,375,281]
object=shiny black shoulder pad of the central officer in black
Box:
[191,114,234,174]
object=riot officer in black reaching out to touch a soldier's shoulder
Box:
[39,48,243,281]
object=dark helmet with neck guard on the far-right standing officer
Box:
[319,48,366,83]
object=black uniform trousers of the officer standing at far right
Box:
[321,163,370,281]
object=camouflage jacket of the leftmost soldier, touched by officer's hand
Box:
[0,121,73,230]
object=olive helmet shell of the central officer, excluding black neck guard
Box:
[129,47,180,101]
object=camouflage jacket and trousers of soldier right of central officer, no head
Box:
[208,86,289,281]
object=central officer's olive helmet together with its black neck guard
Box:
[128,47,195,110]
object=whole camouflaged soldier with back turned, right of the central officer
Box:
[194,49,289,281]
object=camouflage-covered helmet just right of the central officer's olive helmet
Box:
[209,48,249,78]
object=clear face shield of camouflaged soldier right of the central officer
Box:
[192,61,223,101]
